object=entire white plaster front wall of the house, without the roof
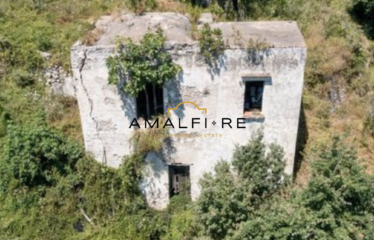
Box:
[72,12,306,208]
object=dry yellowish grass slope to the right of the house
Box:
[243,0,374,183]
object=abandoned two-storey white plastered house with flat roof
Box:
[71,13,306,208]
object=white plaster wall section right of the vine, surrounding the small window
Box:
[139,45,306,207]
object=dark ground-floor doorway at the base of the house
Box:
[169,166,190,198]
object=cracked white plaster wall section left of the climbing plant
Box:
[71,46,135,167]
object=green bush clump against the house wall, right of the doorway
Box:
[197,132,287,239]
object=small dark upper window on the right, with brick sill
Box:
[244,81,264,112]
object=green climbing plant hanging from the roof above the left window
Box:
[107,29,180,96]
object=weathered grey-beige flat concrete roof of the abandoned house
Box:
[76,12,307,49]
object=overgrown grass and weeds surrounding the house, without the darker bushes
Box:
[0,0,374,239]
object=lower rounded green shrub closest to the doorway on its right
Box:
[197,162,253,239]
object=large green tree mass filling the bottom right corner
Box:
[233,138,374,240]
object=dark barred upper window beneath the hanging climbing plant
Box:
[136,84,164,119]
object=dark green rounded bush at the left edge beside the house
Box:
[0,126,83,187]
